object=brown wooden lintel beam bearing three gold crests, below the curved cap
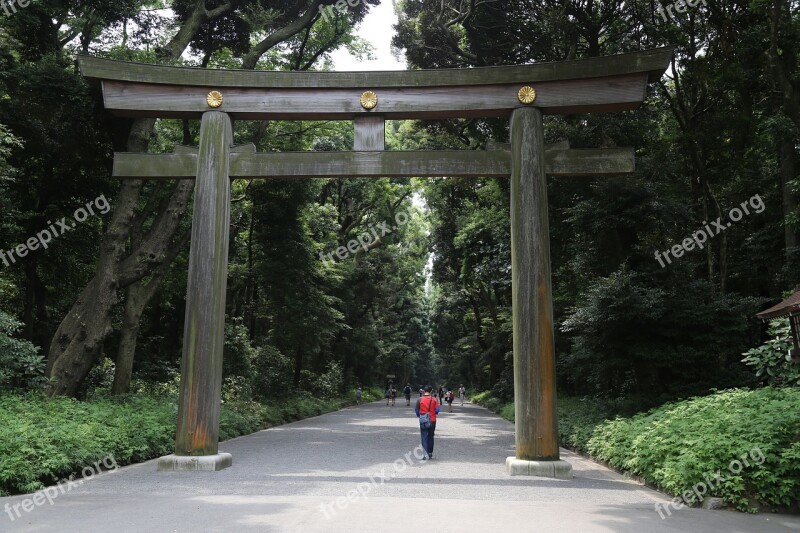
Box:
[103,73,647,120]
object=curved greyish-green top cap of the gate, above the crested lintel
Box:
[78,47,674,90]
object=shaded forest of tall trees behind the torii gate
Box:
[0,0,800,407]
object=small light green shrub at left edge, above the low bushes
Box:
[0,311,48,390]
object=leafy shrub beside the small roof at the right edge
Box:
[742,318,800,386]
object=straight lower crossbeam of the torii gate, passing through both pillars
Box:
[114,148,634,179]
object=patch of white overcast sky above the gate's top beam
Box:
[332,0,406,70]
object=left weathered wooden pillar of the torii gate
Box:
[175,111,233,456]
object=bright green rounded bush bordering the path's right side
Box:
[588,388,800,510]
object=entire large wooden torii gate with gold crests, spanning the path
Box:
[79,48,672,479]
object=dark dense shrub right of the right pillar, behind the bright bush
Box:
[559,270,759,403]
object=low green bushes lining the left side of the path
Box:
[0,384,381,495]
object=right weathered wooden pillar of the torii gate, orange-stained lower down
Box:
[511,108,559,461]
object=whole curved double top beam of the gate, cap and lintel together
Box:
[78,48,672,120]
